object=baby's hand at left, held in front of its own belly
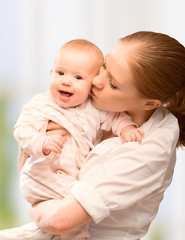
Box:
[42,135,66,155]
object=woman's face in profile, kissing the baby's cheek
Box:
[91,42,143,113]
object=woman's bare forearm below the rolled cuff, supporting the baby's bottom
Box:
[29,194,92,234]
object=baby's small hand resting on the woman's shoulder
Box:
[121,126,144,144]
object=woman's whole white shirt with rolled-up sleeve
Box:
[71,108,179,240]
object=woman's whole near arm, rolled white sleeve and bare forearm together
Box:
[30,109,177,234]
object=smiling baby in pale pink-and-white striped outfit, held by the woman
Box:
[0,39,143,240]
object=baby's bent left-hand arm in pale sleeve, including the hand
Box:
[13,101,65,157]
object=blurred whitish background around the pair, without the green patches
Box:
[0,0,185,240]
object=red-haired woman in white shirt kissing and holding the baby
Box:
[30,32,185,240]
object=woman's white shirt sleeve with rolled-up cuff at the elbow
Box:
[71,123,177,223]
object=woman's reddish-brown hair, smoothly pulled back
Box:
[120,31,185,146]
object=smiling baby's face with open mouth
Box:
[50,49,99,108]
